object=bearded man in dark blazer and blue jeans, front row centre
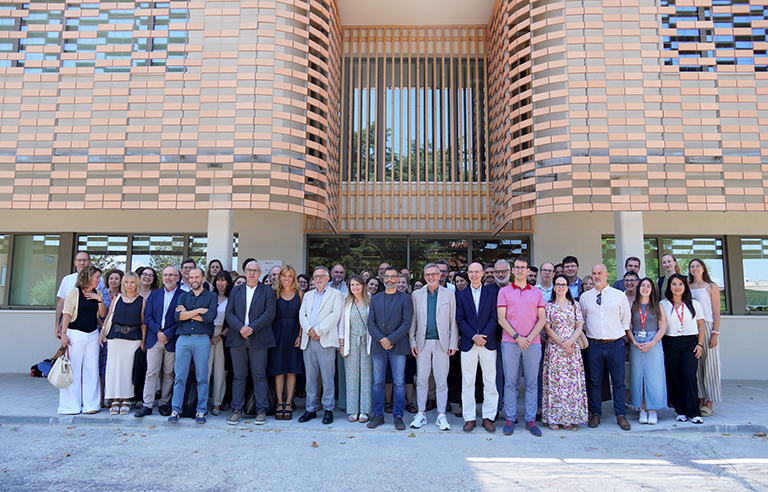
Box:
[368,266,413,430]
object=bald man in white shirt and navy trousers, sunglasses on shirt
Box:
[579,264,631,430]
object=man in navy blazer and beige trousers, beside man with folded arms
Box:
[134,266,182,418]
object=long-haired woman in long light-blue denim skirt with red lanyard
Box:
[624,276,667,425]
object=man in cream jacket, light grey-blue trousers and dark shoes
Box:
[299,266,344,425]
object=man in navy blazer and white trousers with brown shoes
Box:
[456,263,499,432]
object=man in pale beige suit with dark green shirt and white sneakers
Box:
[409,263,459,430]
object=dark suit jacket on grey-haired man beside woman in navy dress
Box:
[224,282,277,349]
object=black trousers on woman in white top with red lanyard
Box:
[662,335,701,418]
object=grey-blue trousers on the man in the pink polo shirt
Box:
[501,342,541,422]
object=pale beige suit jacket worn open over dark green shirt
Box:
[410,286,459,353]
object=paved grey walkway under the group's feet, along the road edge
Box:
[0,374,768,436]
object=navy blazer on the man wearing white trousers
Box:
[456,285,499,352]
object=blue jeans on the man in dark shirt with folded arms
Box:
[171,335,211,413]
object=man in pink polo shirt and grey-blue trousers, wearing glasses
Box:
[496,256,546,437]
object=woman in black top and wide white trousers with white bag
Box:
[59,265,107,415]
